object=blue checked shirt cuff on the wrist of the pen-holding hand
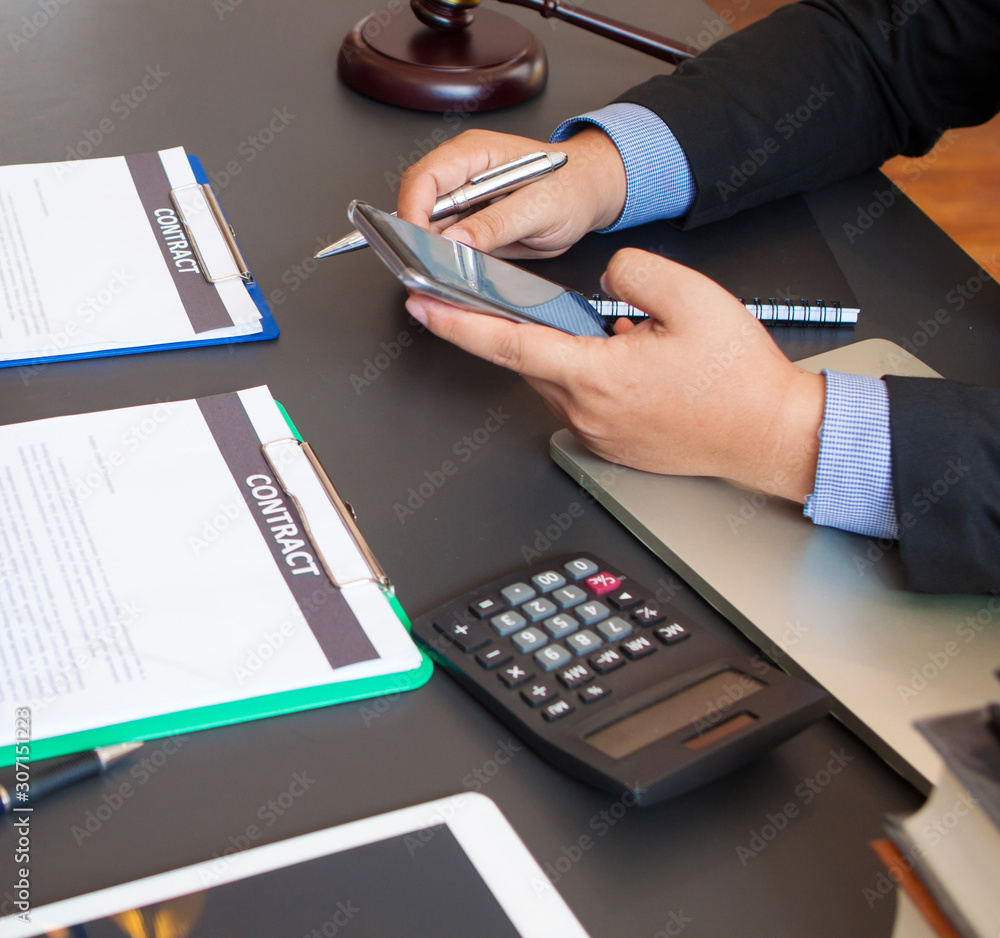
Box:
[551,103,696,233]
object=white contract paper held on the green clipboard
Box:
[0,388,420,745]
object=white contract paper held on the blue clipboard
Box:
[0,147,261,360]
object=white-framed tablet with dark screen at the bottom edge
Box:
[0,793,586,938]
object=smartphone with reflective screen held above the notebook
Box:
[347,201,610,337]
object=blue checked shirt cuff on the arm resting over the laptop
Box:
[805,371,899,540]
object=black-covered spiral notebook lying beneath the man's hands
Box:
[525,196,860,326]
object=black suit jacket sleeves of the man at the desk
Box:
[618,0,1000,592]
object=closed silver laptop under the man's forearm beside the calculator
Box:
[550,339,1000,792]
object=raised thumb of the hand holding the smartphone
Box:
[601,248,752,333]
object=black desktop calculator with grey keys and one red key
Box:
[413,553,829,805]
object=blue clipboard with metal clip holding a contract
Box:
[0,147,279,368]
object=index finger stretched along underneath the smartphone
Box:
[406,294,584,385]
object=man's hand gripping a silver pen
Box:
[396,127,625,258]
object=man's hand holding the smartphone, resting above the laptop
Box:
[407,249,825,502]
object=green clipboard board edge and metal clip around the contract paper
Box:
[0,401,433,767]
